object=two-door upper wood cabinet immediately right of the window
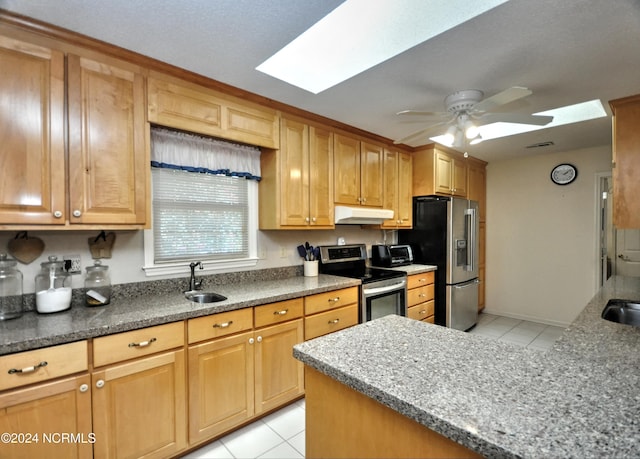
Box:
[259,117,334,229]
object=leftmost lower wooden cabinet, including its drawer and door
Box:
[0,341,95,459]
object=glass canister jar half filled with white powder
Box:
[36,256,71,313]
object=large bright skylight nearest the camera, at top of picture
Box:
[256,0,507,94]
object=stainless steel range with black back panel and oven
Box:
[320,244,407,323]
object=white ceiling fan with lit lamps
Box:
[394,86,553,147]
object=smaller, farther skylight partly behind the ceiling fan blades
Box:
[430,99,607,145]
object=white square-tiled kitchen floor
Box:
[185,314,564,459]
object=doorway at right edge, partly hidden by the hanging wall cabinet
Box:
[597,173,640,288]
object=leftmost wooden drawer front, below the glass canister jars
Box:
[0,341,88,390]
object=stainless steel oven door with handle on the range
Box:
[360,277,407,323]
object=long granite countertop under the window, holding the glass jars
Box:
[0,274,360,355]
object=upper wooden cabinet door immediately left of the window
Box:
[68,55,150,225]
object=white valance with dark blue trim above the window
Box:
[151,127,261,180]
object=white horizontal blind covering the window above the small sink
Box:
[152,168,249,263]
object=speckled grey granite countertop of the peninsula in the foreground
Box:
[294,277,640,458]
